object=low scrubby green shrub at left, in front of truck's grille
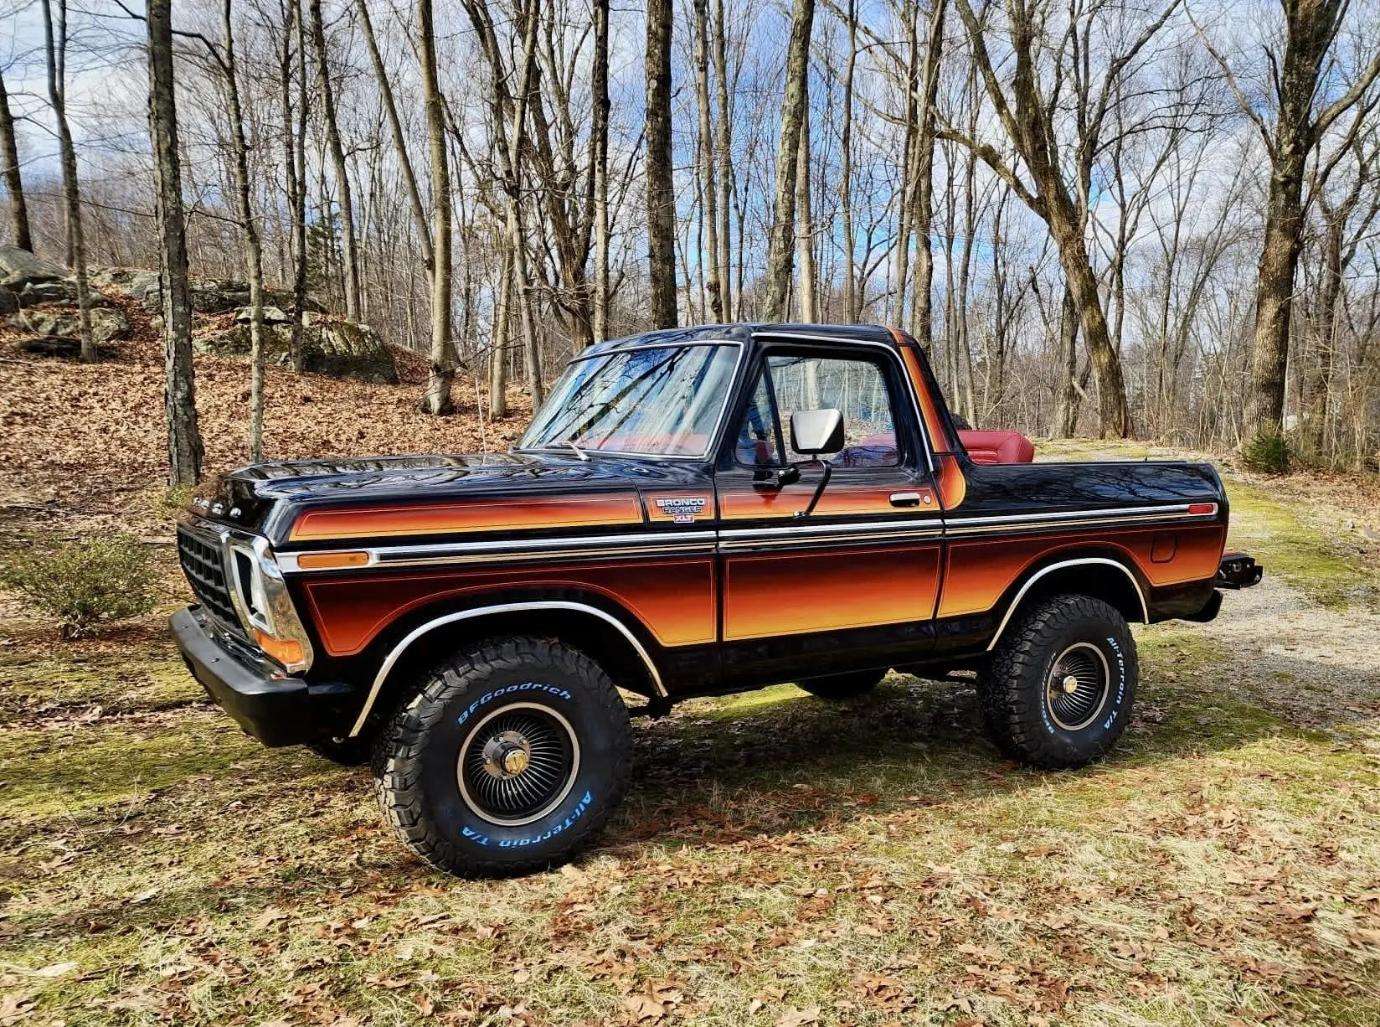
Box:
[0,534,157,638]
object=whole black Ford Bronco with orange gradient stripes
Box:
[173,324,1260,874]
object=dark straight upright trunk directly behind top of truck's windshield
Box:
[644,0,678,329]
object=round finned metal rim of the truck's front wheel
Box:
[455,703,580,827]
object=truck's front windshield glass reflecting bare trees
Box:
[519,345,737,457]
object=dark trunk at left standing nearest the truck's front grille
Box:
[148,0,203,486]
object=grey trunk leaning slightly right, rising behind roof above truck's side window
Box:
[762,0,814,322]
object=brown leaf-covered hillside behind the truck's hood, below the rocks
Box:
[0,278,530,531]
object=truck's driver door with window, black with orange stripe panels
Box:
[716,345,941,676]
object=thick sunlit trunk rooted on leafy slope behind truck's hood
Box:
[414,0,455,414]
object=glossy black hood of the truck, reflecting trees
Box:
[190,451,708,540]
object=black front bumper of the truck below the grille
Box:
[171,606,355,745]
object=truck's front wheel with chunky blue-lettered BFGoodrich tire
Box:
[374,636,632,877]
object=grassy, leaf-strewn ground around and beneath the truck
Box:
[0,332,1380,1027]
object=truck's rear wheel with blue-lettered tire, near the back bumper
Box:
[978,595,1139,769]
